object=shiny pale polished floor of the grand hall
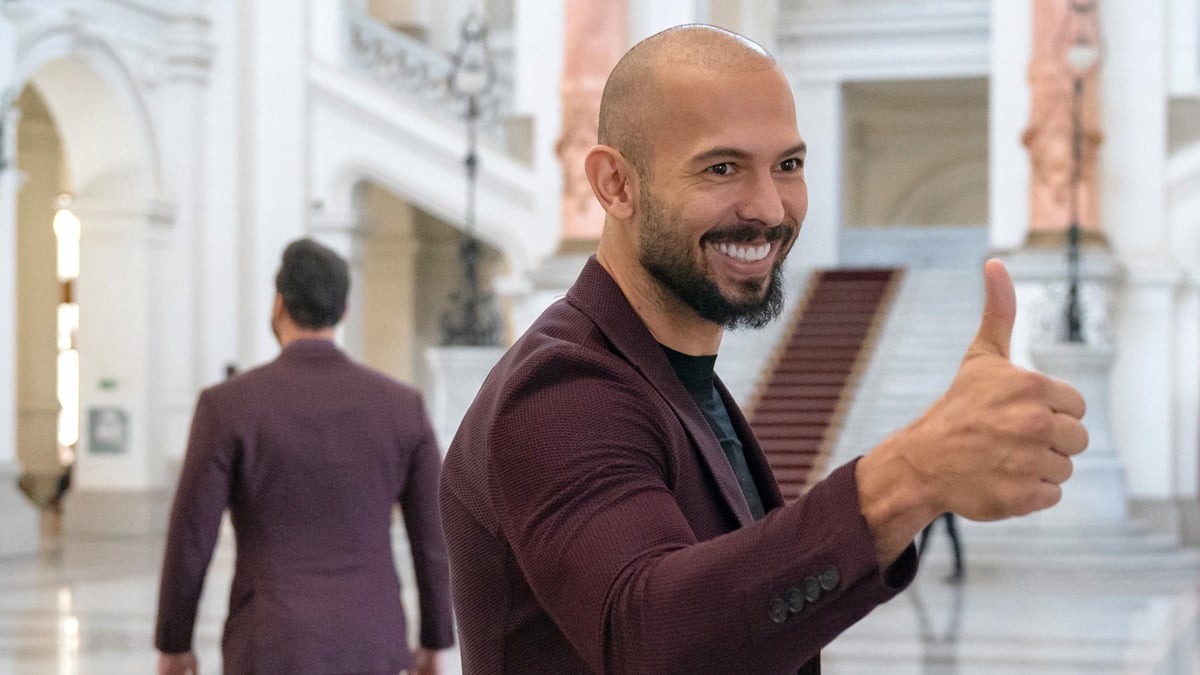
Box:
[0,521,1200,675]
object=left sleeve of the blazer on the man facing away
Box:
[155,390,238,653]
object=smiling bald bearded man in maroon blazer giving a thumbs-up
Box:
[440,25,1087,675]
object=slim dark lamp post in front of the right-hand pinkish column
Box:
[1064,0,1100,342]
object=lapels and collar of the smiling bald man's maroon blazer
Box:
[566,256,775,525]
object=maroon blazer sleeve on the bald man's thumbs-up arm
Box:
[490,348,916,673]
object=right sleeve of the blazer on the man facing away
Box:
[400,398,454,649]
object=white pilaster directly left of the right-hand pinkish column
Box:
[988,0,1033,250]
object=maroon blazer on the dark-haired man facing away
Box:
[155,340,452,675]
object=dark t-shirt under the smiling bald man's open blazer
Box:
[662,346,766,520]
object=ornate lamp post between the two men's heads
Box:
[442,13,500,347]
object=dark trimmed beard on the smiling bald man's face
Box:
[637,190,793,329]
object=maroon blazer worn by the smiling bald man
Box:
[440,258,916,675]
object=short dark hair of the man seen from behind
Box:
[275,238,350,328]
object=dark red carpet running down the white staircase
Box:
[749,269,901,501]
